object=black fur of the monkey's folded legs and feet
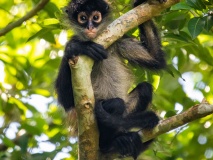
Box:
[95,82,159,159]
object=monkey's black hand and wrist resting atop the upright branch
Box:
[65,37,108,61]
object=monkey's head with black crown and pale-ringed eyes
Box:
[66,0,109,39]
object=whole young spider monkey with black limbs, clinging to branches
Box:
[55,0,166,159]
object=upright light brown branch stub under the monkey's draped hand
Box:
[67,55,99,160]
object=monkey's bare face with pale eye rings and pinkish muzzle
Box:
[77,11,102,39]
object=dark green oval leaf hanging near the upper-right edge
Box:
[188,17,205,39]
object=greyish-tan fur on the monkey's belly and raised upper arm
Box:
[91,38,150,112]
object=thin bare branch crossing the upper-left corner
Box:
[0,0,50,37]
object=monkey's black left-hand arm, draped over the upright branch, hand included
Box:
[55,36,107,110]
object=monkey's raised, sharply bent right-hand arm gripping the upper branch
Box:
[117,0,166,70]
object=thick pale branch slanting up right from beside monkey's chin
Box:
[94,0,180,48]
